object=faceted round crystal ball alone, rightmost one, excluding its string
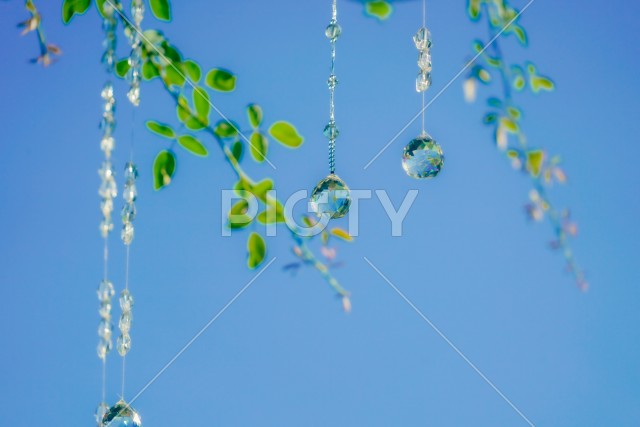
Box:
[402,133,444,179]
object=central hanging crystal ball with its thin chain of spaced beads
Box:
[309,0,351,218]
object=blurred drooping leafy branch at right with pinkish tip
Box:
[464,0,588,290]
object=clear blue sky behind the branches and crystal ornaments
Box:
[0,0,640,427]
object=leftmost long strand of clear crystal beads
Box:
[95,4,117,426]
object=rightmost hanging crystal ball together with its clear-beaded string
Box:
[402,0,444,179]
